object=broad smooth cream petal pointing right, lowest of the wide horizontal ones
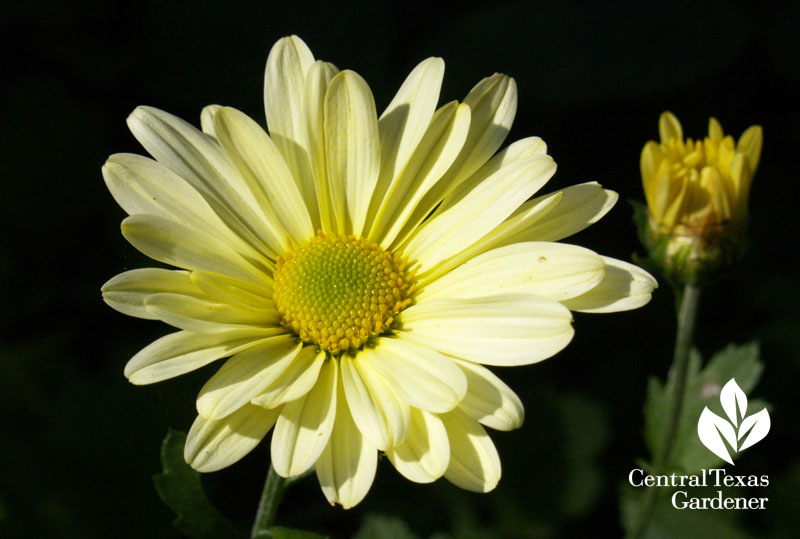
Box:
[398,294,574,366]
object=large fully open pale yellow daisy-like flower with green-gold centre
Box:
[103,36,655,508]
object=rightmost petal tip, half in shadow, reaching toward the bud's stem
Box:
[562,256,658,313]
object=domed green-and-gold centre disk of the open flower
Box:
[273,232,414,354]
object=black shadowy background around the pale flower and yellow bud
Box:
[0,1,800,537]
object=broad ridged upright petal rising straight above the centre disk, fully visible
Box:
[324,71,381,236]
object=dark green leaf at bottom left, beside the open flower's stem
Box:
[153,430,244,538]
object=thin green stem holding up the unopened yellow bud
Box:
[626,284,700,539]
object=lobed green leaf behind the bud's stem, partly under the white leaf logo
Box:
[644,343,767,473]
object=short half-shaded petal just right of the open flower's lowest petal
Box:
[386,408,450,483]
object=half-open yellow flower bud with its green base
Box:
[640,112,763,282]
